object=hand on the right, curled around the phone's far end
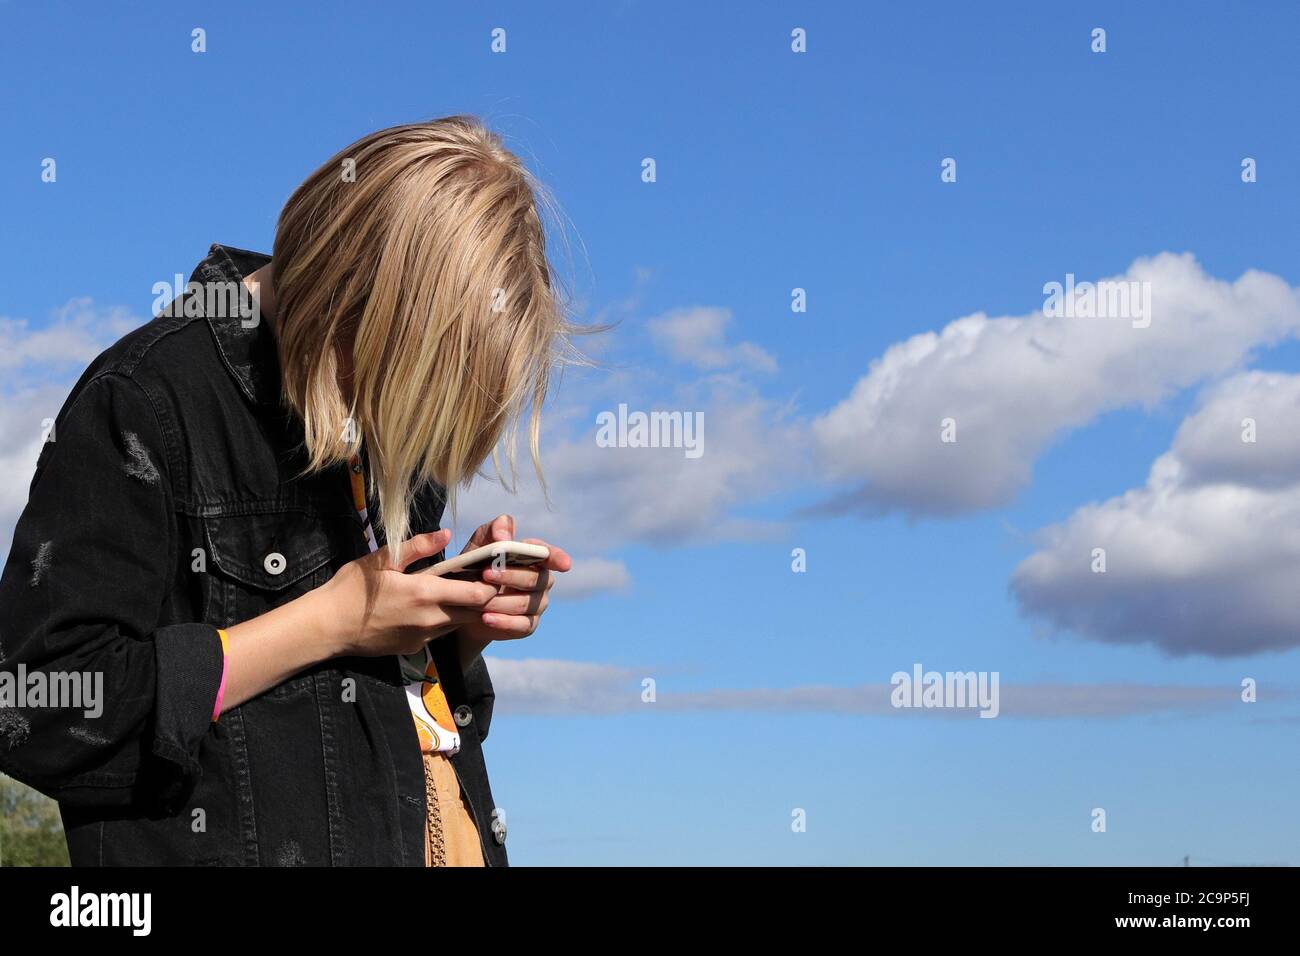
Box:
[447,515,573,666]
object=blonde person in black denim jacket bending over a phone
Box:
[0,117,571,866]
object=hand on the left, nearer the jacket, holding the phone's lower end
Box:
[311,529,497,657]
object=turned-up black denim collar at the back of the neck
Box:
[186,243,281,405]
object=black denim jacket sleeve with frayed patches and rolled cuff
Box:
[0,373,224,812]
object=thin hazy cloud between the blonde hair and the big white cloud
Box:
[456,299,809,596]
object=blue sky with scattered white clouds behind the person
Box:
[0,0,1300,865]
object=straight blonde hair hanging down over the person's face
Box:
[272,116,571,553]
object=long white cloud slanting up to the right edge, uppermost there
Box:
[813,252,1300,515]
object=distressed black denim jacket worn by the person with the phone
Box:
[0,246,506,866]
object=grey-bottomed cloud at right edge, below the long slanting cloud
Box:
[1011,372,1300,657]
